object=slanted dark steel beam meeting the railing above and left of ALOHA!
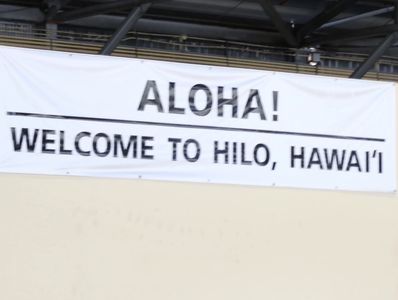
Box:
[100,3,151,55]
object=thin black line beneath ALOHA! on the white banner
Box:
[7,111,386,142]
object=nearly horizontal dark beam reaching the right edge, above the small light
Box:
[308,24,398,45]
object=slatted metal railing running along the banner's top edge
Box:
[0,23,398,81]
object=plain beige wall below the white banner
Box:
[0,175,398,300]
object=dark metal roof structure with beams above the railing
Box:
[0,0,398,78]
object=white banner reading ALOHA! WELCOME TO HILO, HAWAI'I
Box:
[0,47,396,191]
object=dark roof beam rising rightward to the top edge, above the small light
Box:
[297,0,358,41]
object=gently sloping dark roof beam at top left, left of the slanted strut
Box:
[54,0,152,23]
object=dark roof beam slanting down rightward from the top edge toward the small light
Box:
[257,0,298,48]
